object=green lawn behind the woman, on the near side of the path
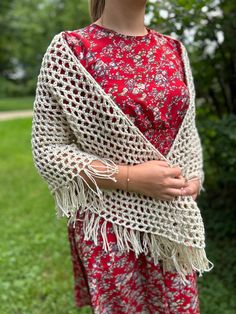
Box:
[0,118,236,314]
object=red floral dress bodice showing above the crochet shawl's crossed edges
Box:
[63,24,189,155]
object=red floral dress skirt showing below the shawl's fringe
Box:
[68,214,199,314]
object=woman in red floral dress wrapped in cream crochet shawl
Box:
[32,0,213,314]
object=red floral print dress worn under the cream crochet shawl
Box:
[65,23,199,314]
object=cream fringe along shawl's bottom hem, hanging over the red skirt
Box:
[79,207,214,284]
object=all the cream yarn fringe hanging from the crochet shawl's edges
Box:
[51,159,214,284]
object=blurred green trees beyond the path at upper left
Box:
[0,0,90,97]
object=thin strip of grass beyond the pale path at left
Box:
[0,96,34,112]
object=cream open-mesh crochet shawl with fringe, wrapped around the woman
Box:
[31,32,213,281]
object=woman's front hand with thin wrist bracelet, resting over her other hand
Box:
[129,160,188,200]
